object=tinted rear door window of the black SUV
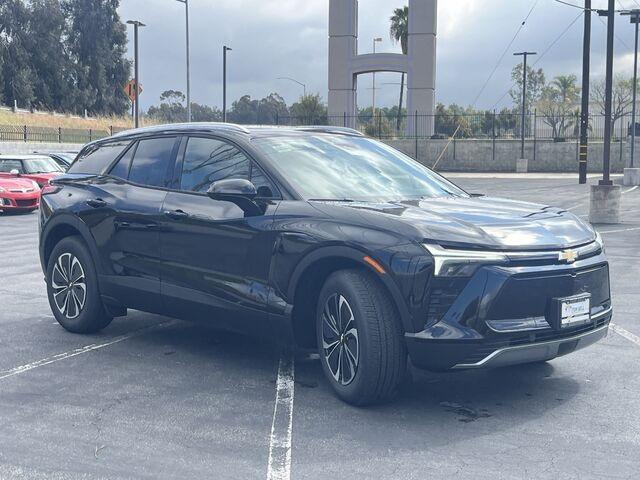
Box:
[129,137,176,187]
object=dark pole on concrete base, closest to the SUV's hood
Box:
[589,0,622,223]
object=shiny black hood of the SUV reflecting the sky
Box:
[312,197,595,250]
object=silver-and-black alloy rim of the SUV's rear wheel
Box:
[51,252,87,319]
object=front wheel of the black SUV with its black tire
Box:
[316,270,407,406]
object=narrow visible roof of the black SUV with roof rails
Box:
[109,122,363,139]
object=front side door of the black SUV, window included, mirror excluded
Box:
[160,136,279,330]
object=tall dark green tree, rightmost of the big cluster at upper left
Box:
[62,0,131,115]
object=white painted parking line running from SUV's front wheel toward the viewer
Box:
[267,353,295,480]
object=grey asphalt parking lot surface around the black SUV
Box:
[0,174,640,480]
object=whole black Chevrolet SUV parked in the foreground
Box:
[40,124,612,405]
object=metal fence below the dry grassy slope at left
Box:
[0,125,124,144]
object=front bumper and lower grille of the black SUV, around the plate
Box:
[405,255,612,371]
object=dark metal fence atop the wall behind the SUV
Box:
[275,112,640,142]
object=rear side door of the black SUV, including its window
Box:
[72,136,179,312]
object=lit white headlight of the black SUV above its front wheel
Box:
[423,243,509,277]
